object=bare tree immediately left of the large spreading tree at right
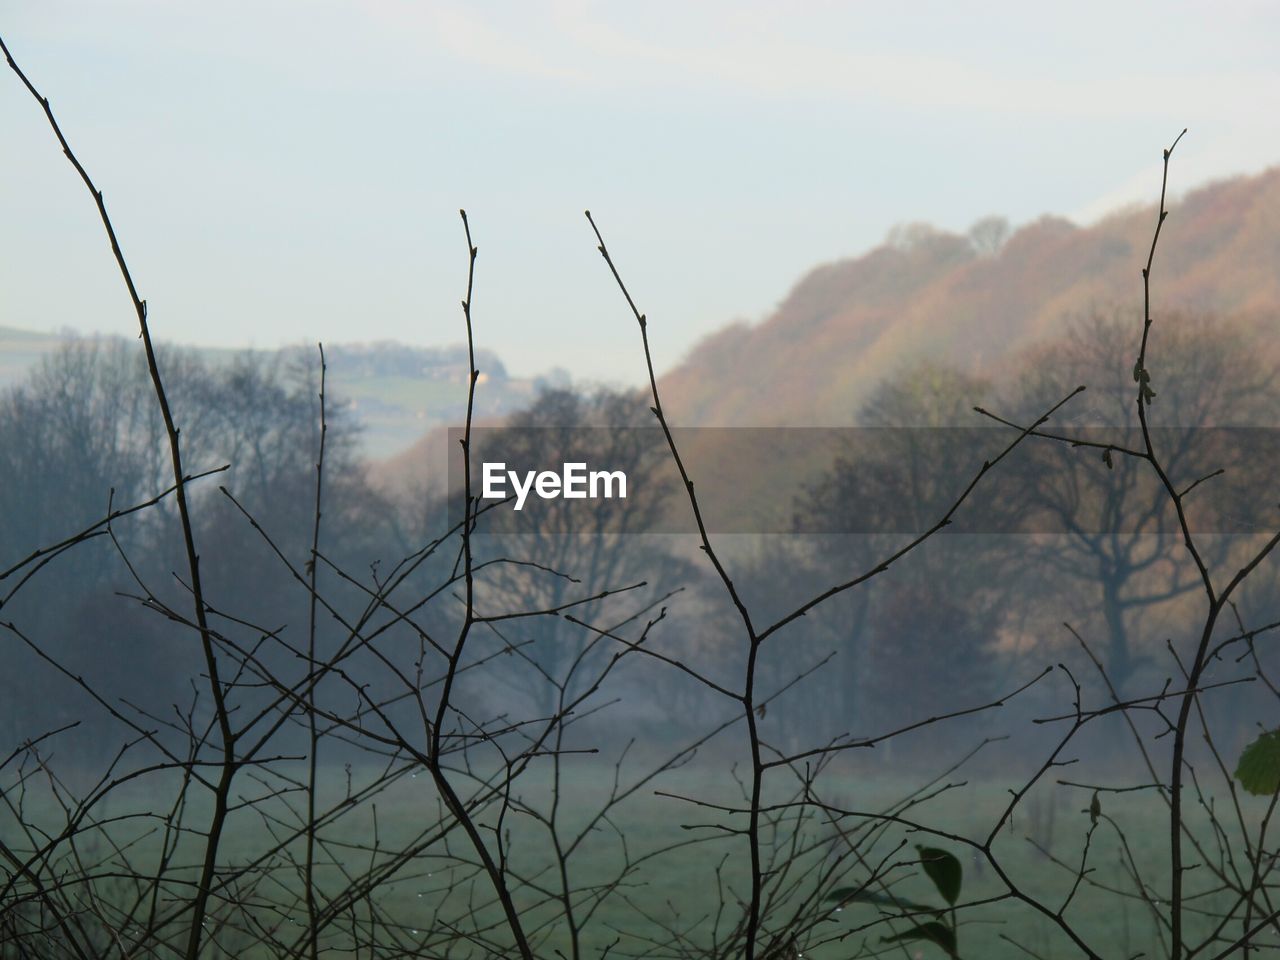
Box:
[796,365,1018,733]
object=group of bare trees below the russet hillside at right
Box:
[746,314,1280,758]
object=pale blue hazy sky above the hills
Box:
[0,0,1280,381]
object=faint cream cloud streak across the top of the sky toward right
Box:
[360,0,1280,128]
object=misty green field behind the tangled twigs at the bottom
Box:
[5,758,1266,960]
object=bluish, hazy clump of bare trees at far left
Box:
[0,339,383,742]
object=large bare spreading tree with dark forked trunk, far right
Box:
[1001,315,1280,690]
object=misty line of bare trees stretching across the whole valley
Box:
[10,316,1280,773]
